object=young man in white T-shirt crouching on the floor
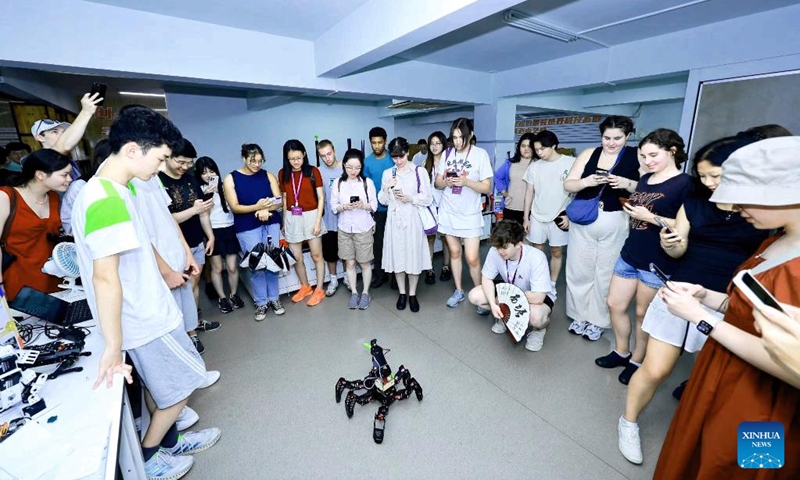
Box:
[469,220,553,352]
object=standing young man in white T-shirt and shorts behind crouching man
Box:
[523,130,575,292]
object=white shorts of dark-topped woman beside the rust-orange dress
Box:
[642,295,722,353]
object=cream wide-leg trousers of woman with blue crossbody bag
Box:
[567,210,628,328]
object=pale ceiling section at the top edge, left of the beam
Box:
[87,0,369,40]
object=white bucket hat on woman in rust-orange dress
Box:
[711,137,800,207]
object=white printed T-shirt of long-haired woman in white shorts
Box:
[436,147,494,229]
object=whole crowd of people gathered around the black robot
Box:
[0,96,800,478]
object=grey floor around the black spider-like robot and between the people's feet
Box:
[186,253,692,480]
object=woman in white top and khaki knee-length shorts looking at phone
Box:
[330,148,378,310]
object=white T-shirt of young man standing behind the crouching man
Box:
[523,155,575,223]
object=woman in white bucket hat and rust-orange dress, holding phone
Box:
[654,137,800,480]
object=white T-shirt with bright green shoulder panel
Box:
[72,176,183,350]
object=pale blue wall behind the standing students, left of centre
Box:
[167,93,394,173]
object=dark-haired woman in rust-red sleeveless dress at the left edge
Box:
[0,149,72,301]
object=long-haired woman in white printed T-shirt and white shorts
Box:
[436,117,494,308]
